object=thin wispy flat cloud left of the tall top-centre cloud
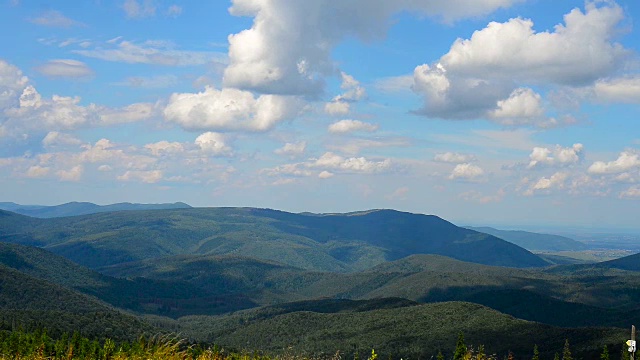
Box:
[72,37,227,66]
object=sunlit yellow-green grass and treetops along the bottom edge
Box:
[0,329,630,360]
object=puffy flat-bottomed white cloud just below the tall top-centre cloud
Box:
[164,87,302,131]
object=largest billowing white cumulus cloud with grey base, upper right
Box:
[413,2,629,128]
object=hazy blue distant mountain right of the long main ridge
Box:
[466,226,588,251]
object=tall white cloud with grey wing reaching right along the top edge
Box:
[224,0,521,95]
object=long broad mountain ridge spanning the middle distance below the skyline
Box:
[0,208,548,272]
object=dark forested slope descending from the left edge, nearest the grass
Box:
[0,265,151,339]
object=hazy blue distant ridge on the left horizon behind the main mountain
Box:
[0,202,191,218]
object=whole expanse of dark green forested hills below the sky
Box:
[0,208,640,359]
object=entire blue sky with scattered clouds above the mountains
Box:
[0,0,640,229]
